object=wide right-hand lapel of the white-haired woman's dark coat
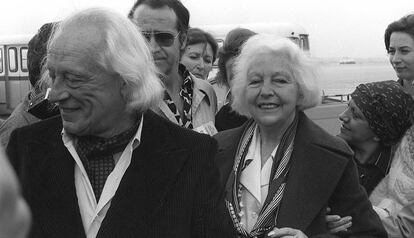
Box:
[277,115,346,231]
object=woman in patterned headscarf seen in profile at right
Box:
[338,81,414,196]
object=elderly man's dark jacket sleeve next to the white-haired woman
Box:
[191,137,235,238]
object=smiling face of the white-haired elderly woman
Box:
[245,53,299,128]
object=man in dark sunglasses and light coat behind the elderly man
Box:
[128,0,217,135]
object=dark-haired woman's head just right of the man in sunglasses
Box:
[181,28,218,80]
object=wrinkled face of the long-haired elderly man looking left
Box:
[47,27,126,137]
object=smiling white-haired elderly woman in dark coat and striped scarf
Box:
[215,35,386,237]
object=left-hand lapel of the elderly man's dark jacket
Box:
[28,129,85,237]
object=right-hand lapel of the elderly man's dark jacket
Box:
[98,112,188,237]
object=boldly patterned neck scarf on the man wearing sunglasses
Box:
[164,64,194,129]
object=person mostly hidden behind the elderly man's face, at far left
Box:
[0,23,59,148]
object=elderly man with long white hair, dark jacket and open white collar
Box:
[7,9,233,238]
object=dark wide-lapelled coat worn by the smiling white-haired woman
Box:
[214,112,387,237]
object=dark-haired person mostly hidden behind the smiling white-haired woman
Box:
[216,28,256,131]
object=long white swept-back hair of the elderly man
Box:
[48,8,163,111]
